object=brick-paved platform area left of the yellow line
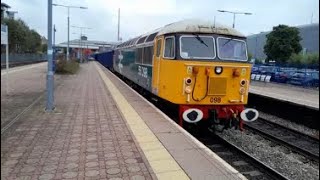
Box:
[1,63,156,180]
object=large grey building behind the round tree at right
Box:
[247,23,319,59]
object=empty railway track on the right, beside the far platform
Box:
[245,118,319,162]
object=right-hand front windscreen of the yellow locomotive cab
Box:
[218,37,248,61]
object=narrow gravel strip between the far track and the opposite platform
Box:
[259,112,319,139]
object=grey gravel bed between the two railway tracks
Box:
[221,129,319,180]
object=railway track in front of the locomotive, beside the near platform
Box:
[194,134,289,180]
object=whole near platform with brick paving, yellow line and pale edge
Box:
[1,62,246,180]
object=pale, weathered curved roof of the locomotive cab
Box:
[118,19,245,47]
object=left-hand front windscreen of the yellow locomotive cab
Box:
[180,34,216,59]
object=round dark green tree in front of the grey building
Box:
[264,25,302,63]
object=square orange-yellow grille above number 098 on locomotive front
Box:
[208,77,227,95]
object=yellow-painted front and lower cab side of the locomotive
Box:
[157,59,251,105]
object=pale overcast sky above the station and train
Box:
[1,0,319,43]
